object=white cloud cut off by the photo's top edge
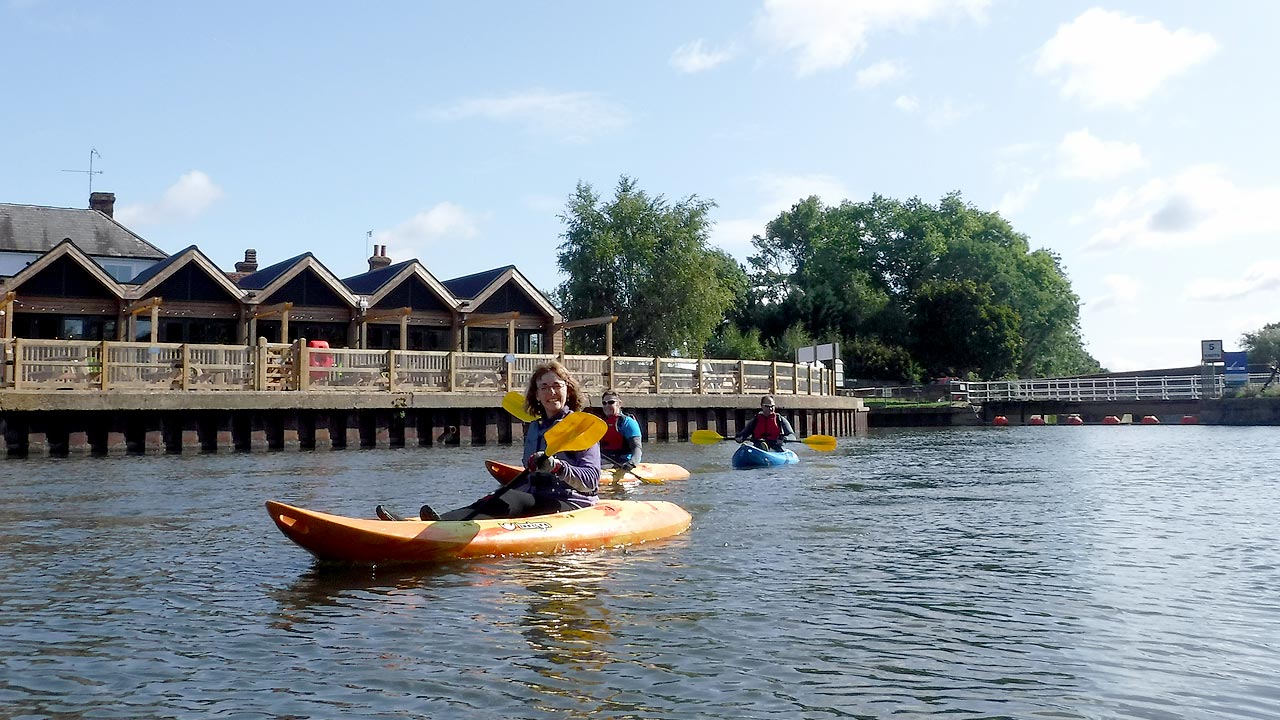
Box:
[755,0,991,76]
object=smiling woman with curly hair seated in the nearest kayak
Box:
[376,361,600,520]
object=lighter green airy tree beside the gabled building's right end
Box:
[556,176,748,356]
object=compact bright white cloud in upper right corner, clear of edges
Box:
[1036,8,1217,109]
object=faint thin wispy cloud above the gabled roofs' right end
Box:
[429,90,630,142]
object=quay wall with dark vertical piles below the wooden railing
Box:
[0,391,867,457]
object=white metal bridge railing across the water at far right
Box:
[968,373,1270,405]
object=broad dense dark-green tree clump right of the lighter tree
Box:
[739,193,1101,379]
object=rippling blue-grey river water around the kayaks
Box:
[0,427,1280,719]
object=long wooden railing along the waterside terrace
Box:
[0,338,835,395]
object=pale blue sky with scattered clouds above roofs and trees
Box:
[0,0,1280,370]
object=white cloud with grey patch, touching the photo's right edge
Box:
[1085,165,1280,251]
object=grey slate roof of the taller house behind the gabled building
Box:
[0,202,169,260]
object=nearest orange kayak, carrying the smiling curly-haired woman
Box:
[266,500,691,565]
